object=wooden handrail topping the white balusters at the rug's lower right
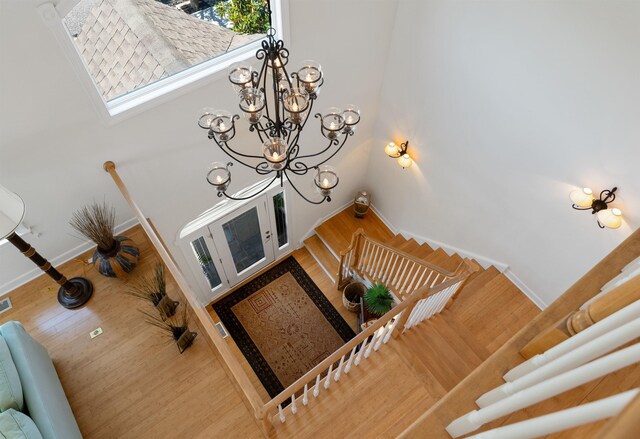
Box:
[265,264,472,412]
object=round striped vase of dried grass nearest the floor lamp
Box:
[69,203,140,277]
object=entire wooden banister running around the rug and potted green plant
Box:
[104,162,478,437]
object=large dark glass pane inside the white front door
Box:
[222,207,264,273]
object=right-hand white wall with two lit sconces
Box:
[368,0,640,303]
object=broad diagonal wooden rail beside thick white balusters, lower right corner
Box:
[400,229,640,438]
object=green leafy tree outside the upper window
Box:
[215,0,269,34]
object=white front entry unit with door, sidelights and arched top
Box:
[180,187,290,304]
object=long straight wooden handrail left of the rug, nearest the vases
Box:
[103,161,264,419]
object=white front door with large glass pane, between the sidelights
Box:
[209,197,277,285]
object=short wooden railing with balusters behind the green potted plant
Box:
[336,229,464,300]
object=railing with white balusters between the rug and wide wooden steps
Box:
[264,261,478,428]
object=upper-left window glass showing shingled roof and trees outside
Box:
[63,0,279,115]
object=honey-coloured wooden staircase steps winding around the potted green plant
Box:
[262,209,538,438]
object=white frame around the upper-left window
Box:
[37,0,290,125]
